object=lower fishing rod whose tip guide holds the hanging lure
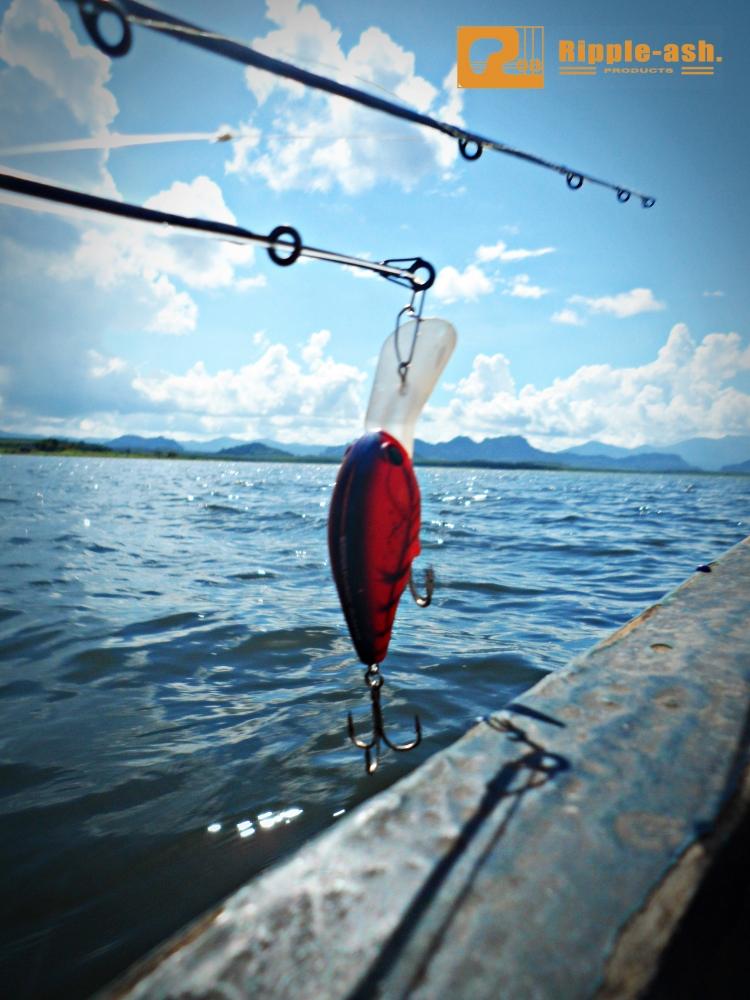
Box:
[0,170,435,294]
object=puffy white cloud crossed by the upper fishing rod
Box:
[226,0,462,194]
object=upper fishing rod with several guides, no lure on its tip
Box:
[69,0,656,208]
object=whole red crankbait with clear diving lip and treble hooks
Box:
[328,307,456,774]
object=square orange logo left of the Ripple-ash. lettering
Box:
[457,25,544,87]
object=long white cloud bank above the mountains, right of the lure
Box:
[427,323,750,446]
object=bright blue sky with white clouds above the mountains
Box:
[0,0,750,449]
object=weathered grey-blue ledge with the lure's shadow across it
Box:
[104,539,750,1000]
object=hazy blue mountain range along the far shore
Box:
[0,431,750,475]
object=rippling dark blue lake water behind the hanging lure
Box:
[0,456,750,1000]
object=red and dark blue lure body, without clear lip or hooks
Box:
[328,431,420,666]
